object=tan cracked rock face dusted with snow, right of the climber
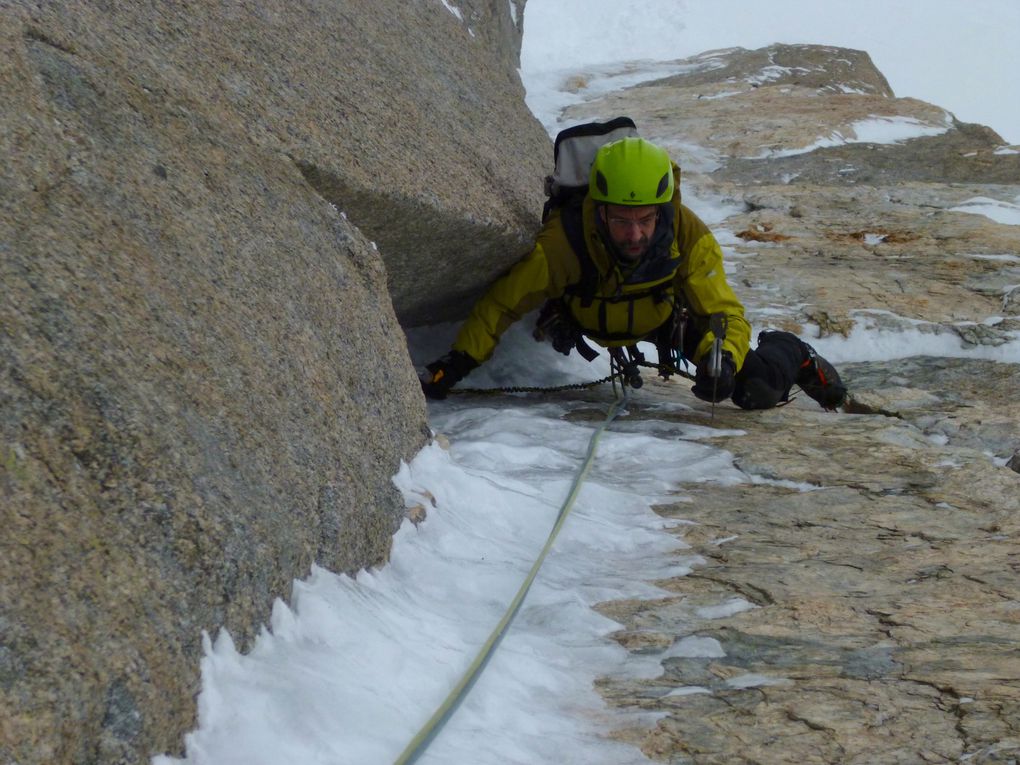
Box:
[568,46,1020,764]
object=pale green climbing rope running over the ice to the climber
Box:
[394,389,629,765]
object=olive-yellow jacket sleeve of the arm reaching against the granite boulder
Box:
[453,224,580,363]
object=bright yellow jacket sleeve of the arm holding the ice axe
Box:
[677,206,751,370]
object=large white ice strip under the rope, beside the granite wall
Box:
[154,400,709,765]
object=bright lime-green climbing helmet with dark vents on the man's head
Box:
[588,138,673,206]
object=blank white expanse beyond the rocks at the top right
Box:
[521,0,1020,144]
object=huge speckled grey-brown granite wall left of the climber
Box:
[0,0,549,765]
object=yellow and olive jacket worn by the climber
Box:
[453,169,751,369]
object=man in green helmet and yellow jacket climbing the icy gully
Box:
[421,136,847,409]
